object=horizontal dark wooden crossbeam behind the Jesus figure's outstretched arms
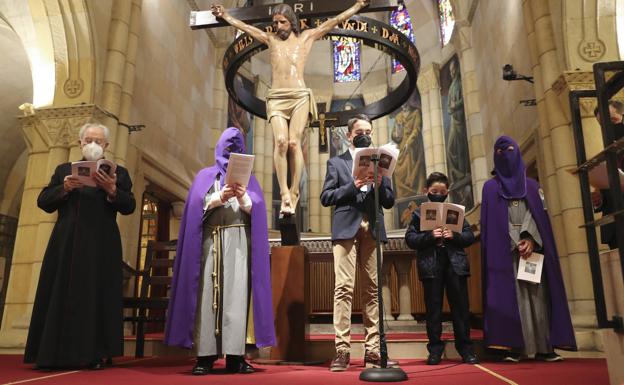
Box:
[190,0,397,29]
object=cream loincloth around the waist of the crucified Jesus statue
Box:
[266,88,318,122]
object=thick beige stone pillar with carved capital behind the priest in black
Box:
[0,104,103,353]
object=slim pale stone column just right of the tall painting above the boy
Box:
[452,19,489,203]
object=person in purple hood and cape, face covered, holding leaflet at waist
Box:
[481,136,576,362]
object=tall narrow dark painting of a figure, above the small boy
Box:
[440,55,474,210]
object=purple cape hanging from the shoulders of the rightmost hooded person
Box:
[481,177,576,350]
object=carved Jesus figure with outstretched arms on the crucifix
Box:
[211,0,367,215]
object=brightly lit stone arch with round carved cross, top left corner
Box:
[0,0,96,108]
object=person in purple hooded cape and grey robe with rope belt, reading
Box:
[165,127,275,375]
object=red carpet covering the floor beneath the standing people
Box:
[0,356,609,385]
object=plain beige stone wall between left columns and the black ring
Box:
[131,2,226,180]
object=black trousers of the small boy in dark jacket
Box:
[422,252,474,356]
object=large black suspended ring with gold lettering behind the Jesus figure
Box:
[223,15,420,126]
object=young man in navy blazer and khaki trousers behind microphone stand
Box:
[321,114,396,372]
